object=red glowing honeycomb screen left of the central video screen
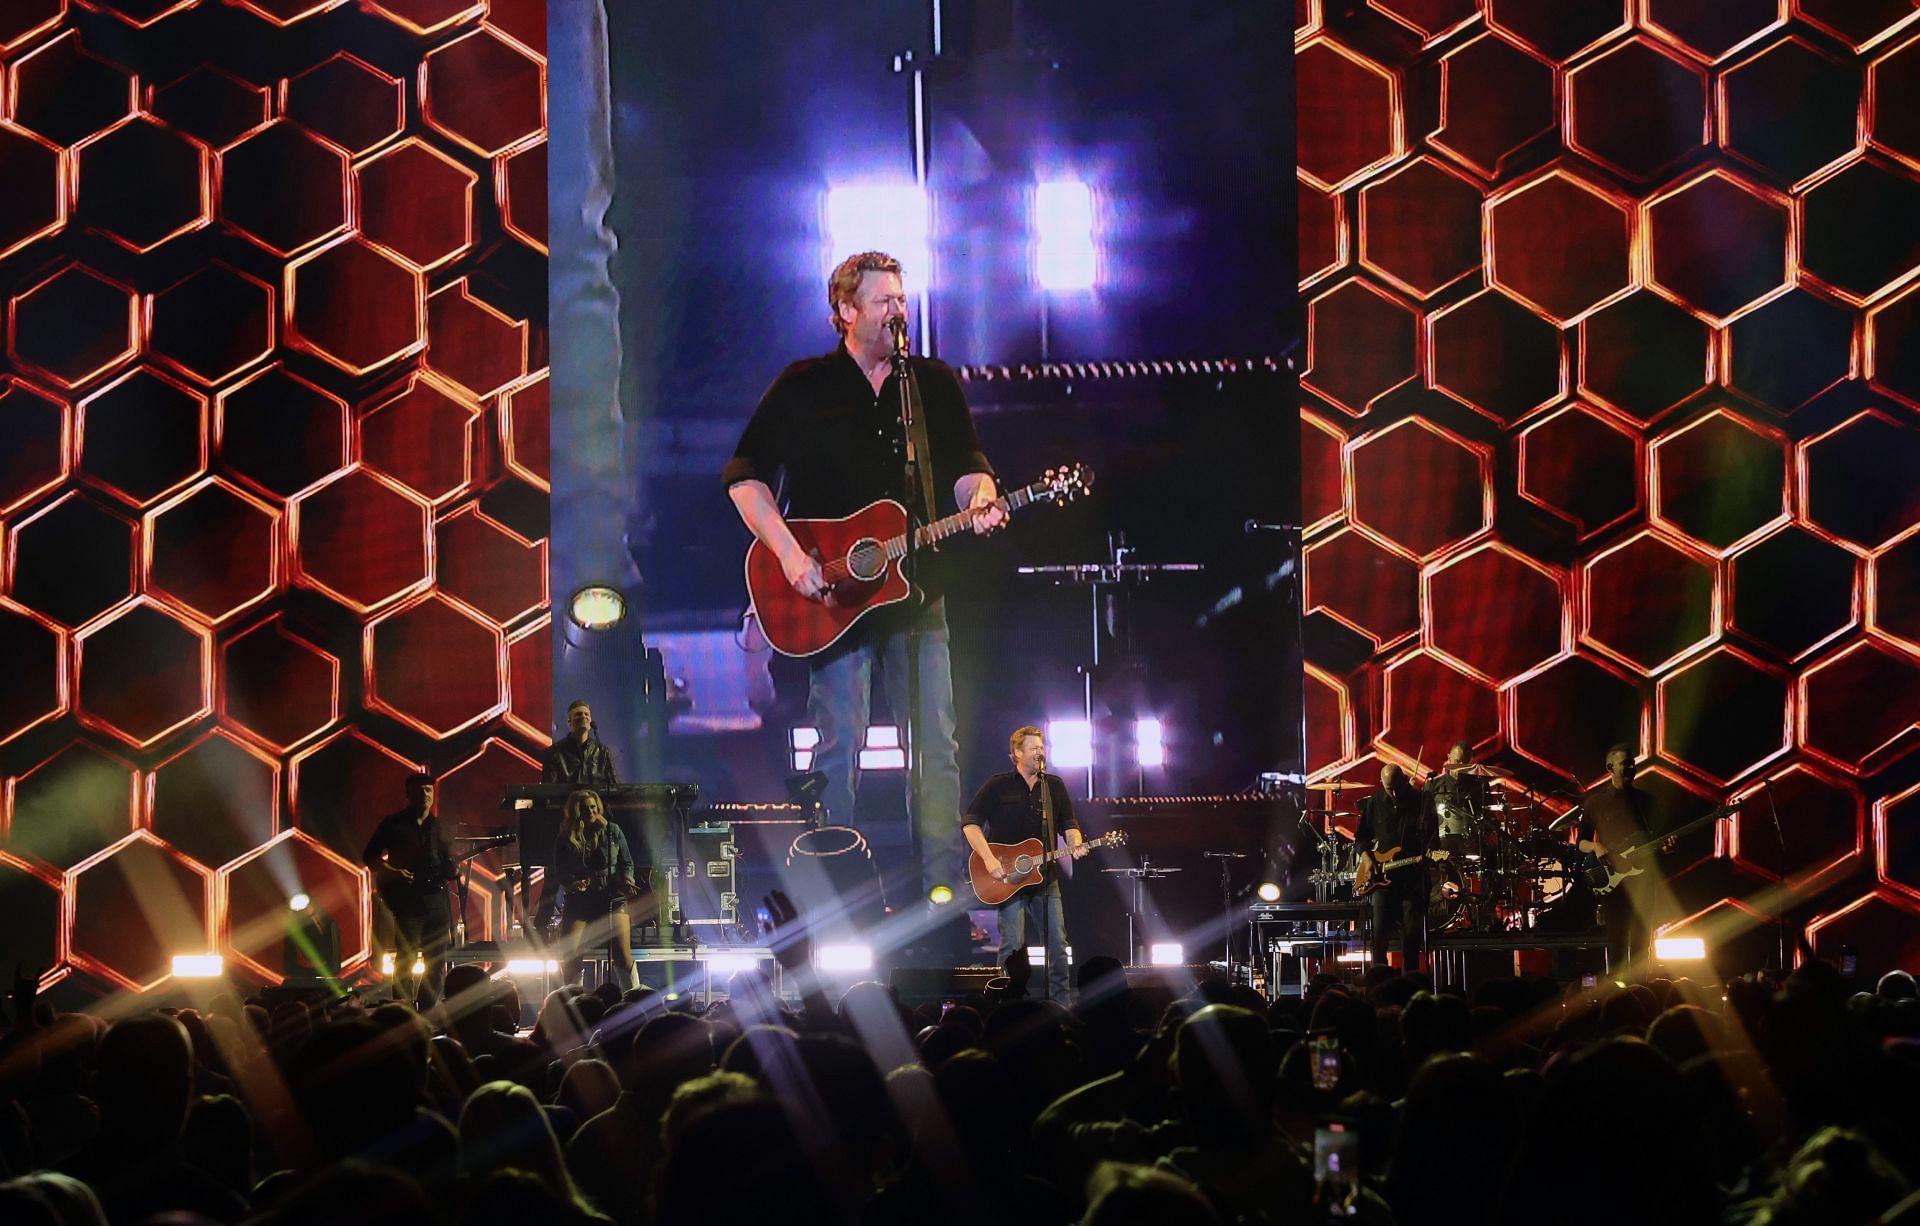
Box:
[0,0,551,994]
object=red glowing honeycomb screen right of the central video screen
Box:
[1296,0,1920,967]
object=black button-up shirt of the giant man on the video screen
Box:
[722,345,993,597]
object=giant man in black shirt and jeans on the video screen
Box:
[722,251,1006,898]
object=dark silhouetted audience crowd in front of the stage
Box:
[0,901,1920,1226]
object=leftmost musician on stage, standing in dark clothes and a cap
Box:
[361,775,453,1009]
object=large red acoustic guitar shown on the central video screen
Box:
[747,464,1092,656]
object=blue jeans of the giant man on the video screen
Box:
[806,610,966,898]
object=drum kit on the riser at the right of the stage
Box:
[1302,764,1578,934]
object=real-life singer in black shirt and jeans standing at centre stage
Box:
[960,725,1087,1005]
